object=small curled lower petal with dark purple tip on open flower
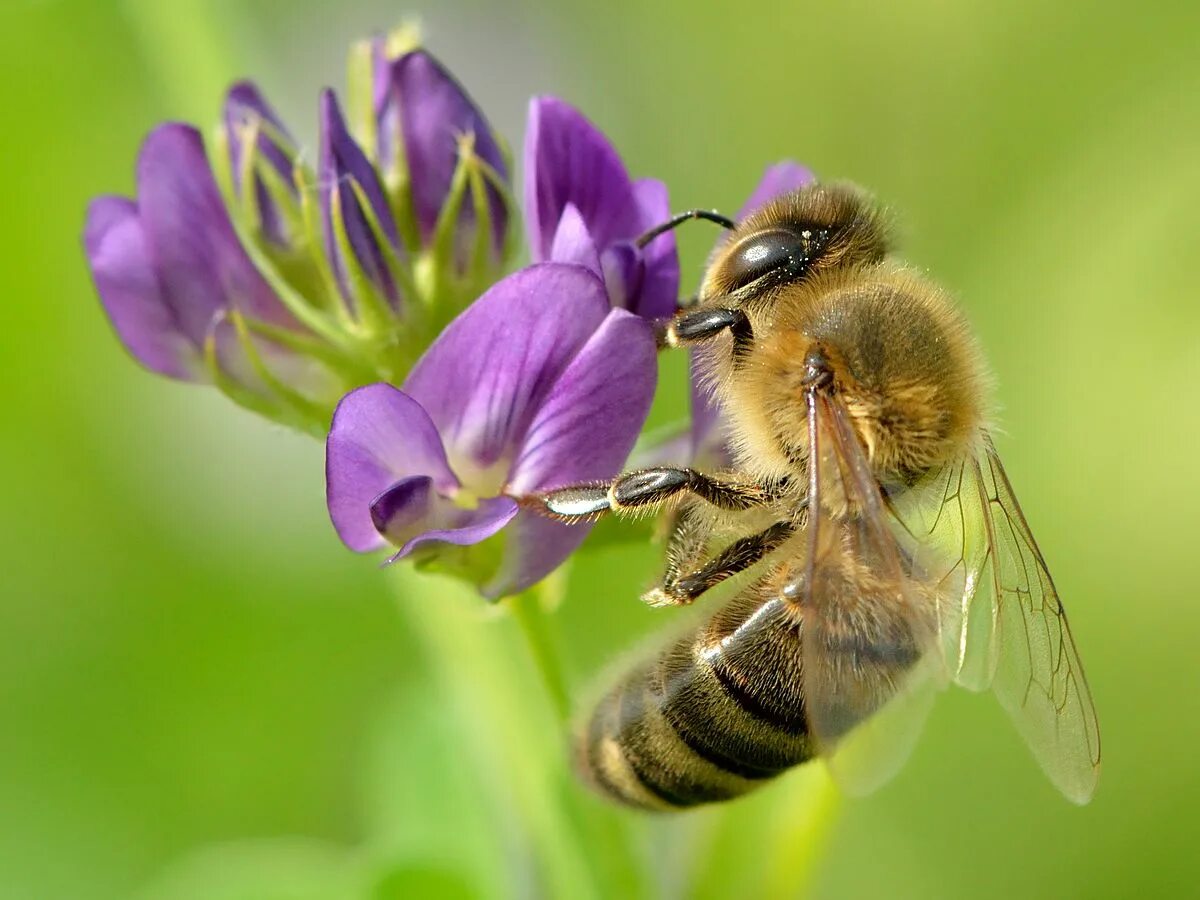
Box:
[371,487,517,563]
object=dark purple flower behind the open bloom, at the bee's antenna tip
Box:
[524,97,679,318]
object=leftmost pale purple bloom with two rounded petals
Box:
[84,124,300,382]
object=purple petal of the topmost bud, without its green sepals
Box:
[386,50,509,250]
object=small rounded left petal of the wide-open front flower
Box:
[325,384,458,552]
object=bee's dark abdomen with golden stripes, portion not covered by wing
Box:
[580,589,812,809]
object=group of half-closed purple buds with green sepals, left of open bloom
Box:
[84,29,512,434]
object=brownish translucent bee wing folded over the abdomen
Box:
[790,394,946,793]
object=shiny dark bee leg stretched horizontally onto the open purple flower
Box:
[527,467,770,522]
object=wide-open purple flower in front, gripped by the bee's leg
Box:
[326,263,655,598]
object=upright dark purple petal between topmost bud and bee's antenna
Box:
[524,97,641,260]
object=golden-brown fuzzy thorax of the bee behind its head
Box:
[709,263,988,480]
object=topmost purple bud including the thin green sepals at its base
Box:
[374,49,509,262]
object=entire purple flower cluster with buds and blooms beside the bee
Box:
[84,32,811,598]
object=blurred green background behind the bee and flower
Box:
[0,0,1200,900]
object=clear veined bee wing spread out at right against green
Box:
[888,436,1100,803]
